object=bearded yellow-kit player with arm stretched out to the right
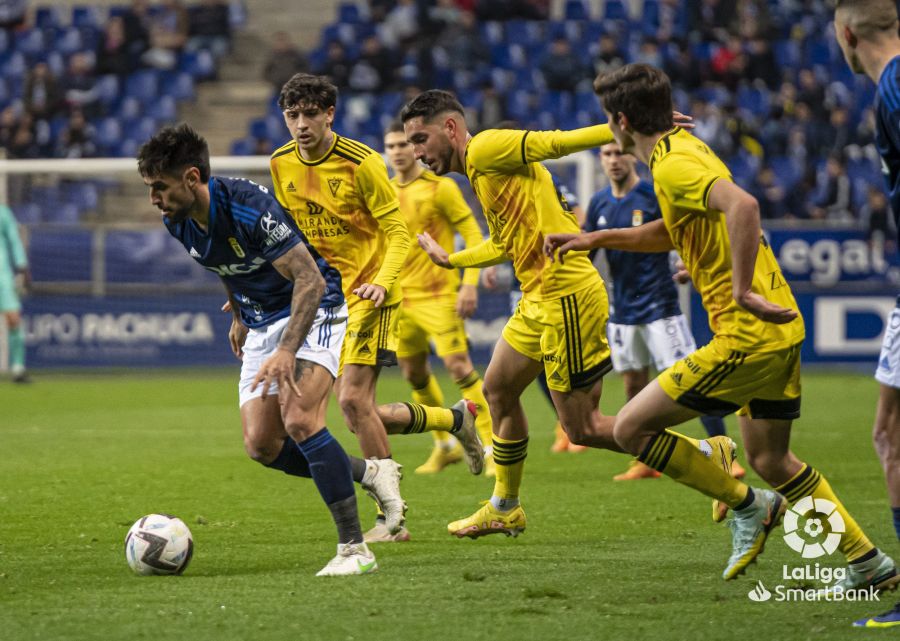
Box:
[401,90,636,537]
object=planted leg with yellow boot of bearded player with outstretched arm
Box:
[447,338,543,538]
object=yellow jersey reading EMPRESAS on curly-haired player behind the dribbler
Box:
[270,134,410,309]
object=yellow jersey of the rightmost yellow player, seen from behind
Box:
[650,127,805,352]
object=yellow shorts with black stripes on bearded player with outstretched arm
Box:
[503,278,612,392]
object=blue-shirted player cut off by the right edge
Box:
[834,0,900,628]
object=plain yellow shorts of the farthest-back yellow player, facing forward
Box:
[397,295,469,358]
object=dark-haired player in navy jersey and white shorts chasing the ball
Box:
[138,124,402,576]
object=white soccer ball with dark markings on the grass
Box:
[125,514,194,575]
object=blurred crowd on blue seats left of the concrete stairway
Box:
[0,0,233,158]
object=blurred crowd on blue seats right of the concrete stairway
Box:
[243,0,890,232]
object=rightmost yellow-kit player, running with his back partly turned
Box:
[545,64,900,594]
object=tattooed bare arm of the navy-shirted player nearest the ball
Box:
[251,244,325,398]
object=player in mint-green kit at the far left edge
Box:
[0,205,31,383]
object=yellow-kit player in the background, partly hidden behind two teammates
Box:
[384,121,492,476]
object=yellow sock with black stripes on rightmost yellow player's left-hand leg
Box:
[638,430,749,508]
